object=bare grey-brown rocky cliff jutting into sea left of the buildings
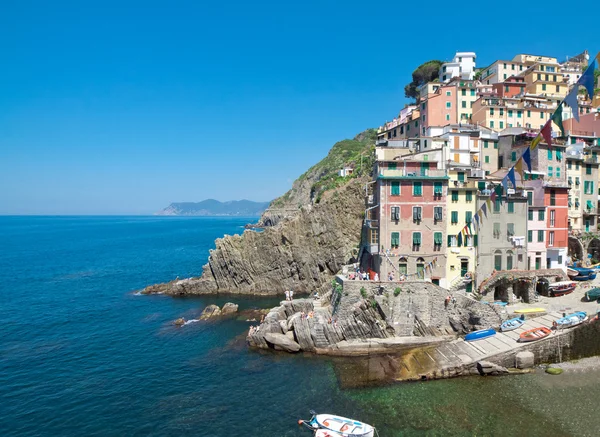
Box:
[142,179,365,295]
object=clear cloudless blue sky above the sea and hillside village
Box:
[0,0,600,214]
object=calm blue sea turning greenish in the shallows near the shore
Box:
[0,217,600,437]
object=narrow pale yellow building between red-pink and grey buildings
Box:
[446,167,485,292]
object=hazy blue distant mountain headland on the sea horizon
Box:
[155,199,270,216]
